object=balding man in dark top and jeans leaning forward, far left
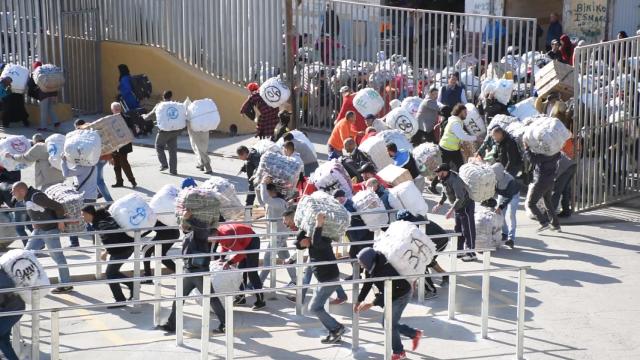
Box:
[11,181,73,294]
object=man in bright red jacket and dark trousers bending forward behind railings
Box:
[214,224,267,310]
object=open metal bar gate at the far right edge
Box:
[573,36,640,210]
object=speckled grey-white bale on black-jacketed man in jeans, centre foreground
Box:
[293,191,351,241]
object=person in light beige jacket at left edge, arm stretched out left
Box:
[5,134,64,191]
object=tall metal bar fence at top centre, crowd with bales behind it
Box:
[293,0,536,130]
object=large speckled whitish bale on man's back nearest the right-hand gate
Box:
[522,117,571,156]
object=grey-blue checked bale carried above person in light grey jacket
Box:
[254,152,303,197]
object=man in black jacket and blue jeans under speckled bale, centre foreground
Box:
[296,213,345,344]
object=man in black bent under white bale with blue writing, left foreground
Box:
[82,205,133,309]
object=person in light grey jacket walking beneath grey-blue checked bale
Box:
[257,176,296,285]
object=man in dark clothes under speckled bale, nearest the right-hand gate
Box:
[524,148,561,232]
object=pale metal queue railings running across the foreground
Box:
[0,219,526,359]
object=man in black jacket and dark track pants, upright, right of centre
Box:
[433,163,476,261]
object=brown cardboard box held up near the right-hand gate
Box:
[535,61,575,100]
